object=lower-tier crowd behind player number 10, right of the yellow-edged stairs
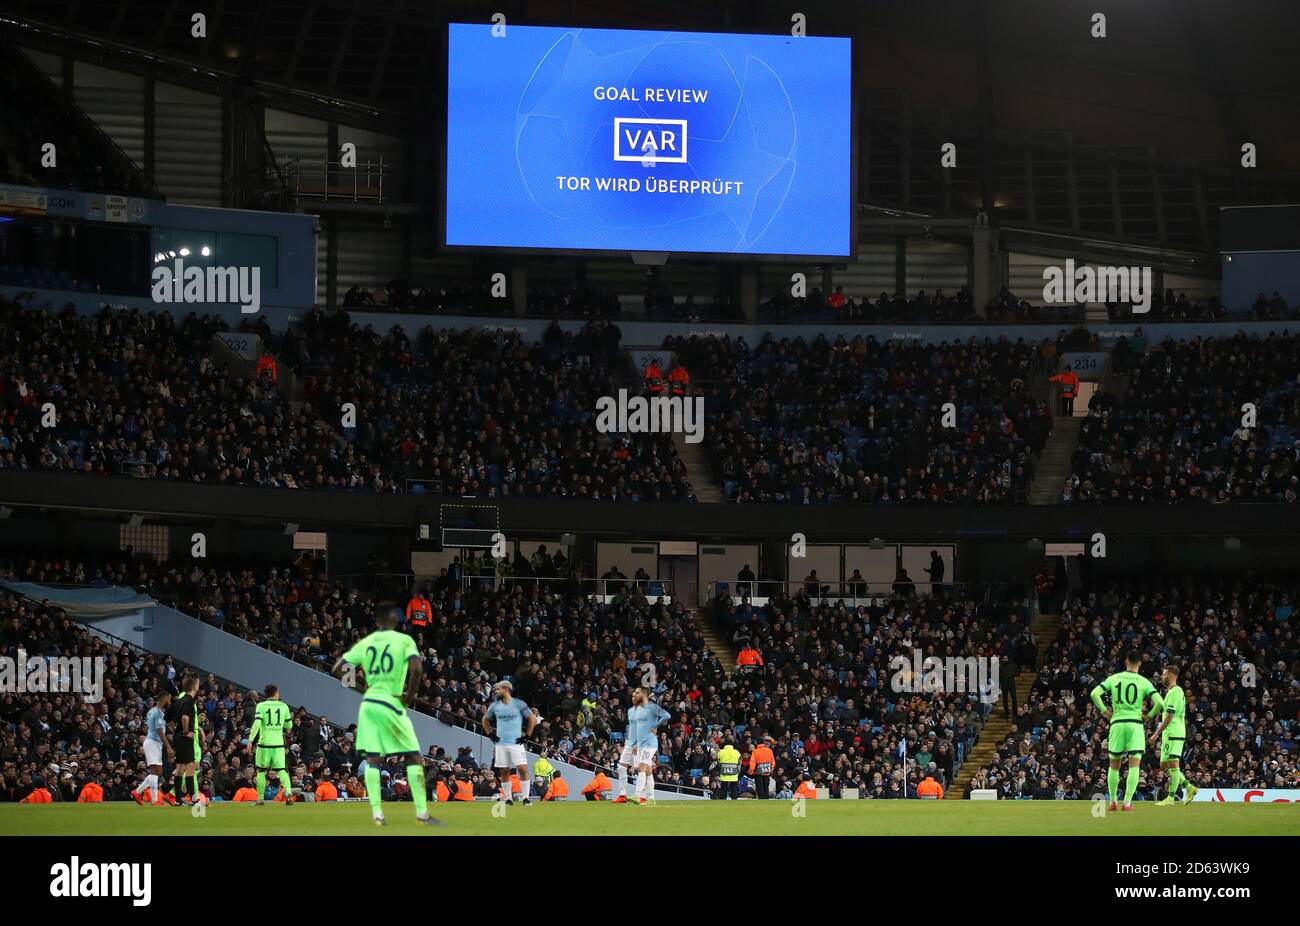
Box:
[972,574,1300,800]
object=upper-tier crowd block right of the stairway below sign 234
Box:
[1061,332,1300,505]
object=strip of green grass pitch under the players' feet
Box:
[0,800,1300,836]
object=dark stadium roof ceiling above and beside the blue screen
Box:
[0,0,1300,170]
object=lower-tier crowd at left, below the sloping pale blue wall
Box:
[0,577,574,802]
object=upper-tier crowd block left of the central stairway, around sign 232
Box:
[0,297,692,501]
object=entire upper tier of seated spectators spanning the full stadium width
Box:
[0,291,1300,505]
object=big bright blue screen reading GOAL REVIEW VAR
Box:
[442,23,854,258]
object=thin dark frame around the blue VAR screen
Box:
[434,21,862,265]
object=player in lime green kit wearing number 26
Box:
[334,601,443,826]
